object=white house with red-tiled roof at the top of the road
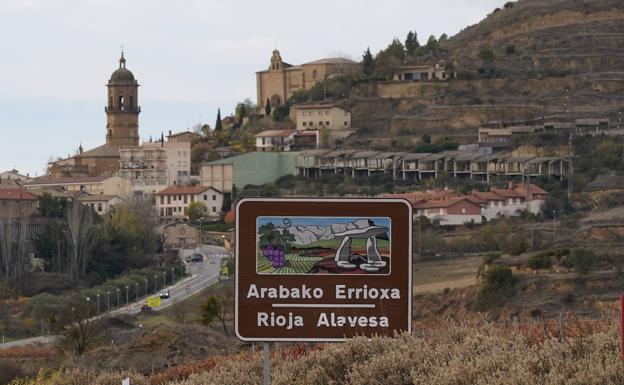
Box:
[156,186,223,221]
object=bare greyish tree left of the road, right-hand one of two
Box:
[66,200,95,278]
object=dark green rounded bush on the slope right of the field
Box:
[475,266,516,310]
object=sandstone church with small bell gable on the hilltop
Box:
[256,50,360,107]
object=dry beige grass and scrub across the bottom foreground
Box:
[13,322,624,385]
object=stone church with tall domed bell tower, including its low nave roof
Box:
[48,52,141,177]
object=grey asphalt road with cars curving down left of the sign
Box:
[0,245,230,349]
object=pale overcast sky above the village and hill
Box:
[0,0,505,175]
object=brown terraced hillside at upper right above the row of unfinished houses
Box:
[342,0,624,147]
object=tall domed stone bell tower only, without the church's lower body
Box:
[104,52,141,146]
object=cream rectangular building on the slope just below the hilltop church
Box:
[291,103,351,131]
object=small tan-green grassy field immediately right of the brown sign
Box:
[413,257,482,294]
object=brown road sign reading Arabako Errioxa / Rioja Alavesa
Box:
[235,198,412,341]
